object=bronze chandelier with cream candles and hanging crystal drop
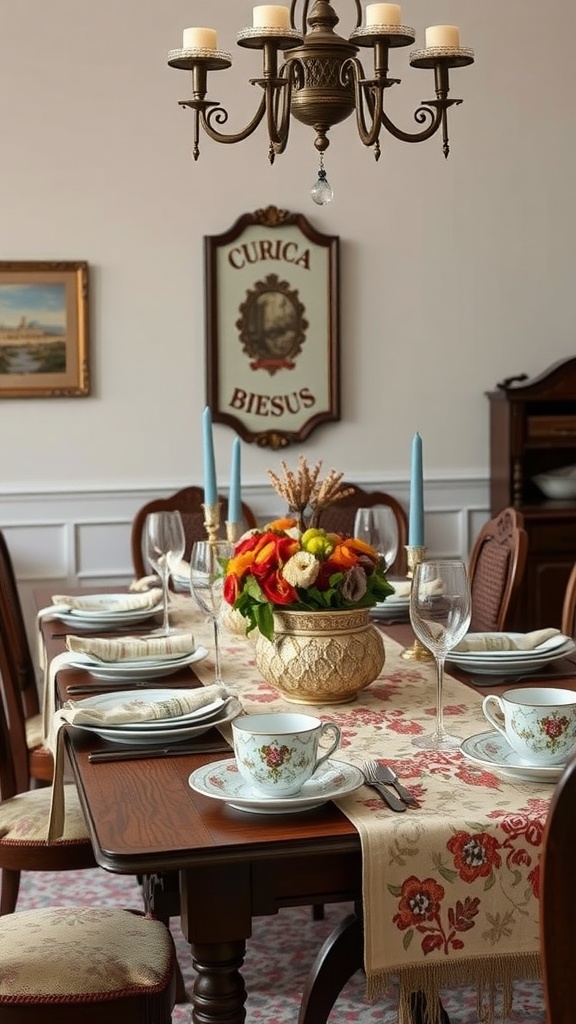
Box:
[168,0,474,204]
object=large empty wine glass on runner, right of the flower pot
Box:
[410,559,471,751]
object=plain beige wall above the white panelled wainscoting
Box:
[0,0,576,495]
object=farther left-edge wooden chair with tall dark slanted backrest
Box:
[0,530,54,792]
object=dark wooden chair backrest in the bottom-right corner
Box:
[540,758,576,1024]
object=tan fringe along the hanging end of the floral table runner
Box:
[366,953,541,1024]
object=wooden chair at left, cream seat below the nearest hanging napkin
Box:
[0,618,96,917]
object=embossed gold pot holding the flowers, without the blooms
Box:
[256,608,385,705]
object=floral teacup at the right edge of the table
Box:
[482,686,576,765]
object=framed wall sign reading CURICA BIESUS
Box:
[204,206,340,449]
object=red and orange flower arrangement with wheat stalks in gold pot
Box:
[224,458,393,703]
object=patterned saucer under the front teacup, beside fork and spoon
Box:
[188,758,364,814]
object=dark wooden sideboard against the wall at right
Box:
[487,357,576,630]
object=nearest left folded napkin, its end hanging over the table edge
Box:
[48,683,231,843]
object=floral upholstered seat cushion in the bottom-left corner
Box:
[0,906,175,995]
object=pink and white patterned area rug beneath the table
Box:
[17,868,545,1024]
